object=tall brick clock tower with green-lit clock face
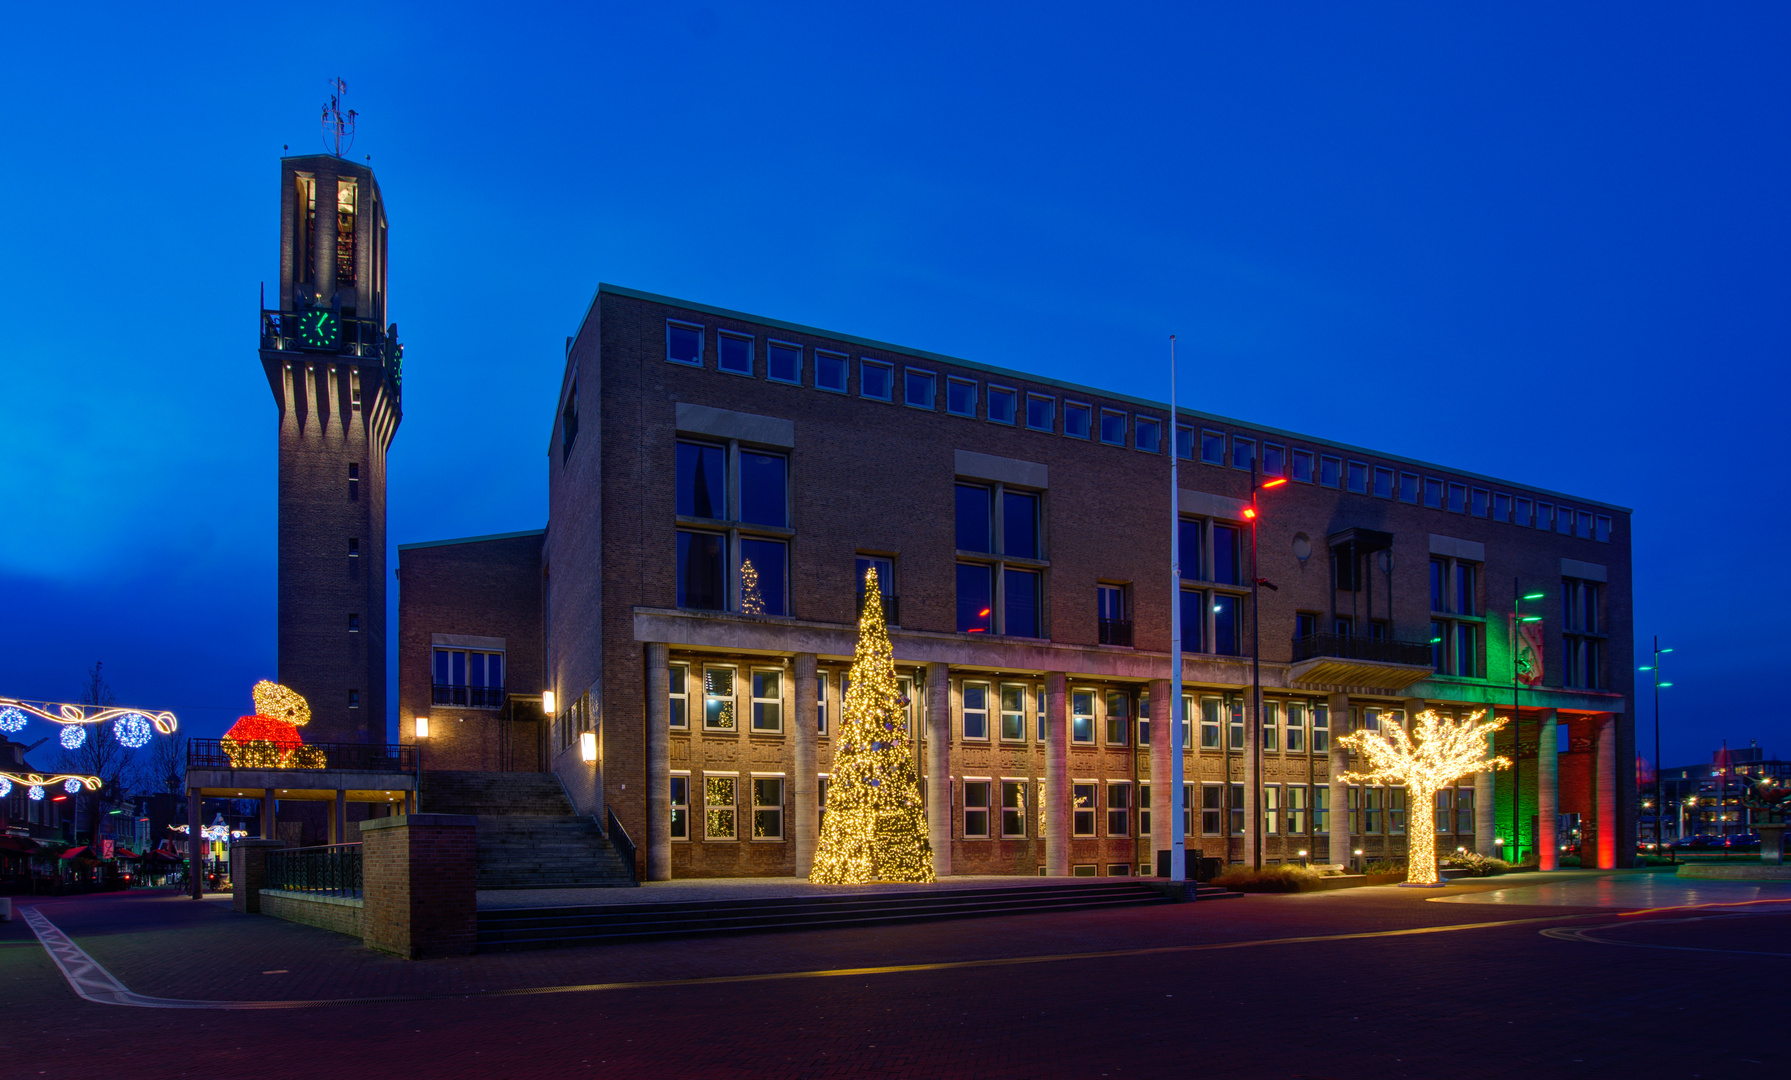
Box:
[261,154,403,743]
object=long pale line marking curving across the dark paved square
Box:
[23,906,1605,1010]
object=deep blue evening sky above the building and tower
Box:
[0,2,1791,763]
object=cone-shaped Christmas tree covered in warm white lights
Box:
[808,570,933,885]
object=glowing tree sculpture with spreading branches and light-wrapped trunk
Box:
[1338,709,1512,885]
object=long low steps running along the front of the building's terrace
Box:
[478,879,1241,953]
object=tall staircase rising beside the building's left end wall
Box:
[417,772,636,888]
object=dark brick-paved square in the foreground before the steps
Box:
[0,872,1791,1080]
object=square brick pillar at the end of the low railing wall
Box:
[360,813,478,960]
